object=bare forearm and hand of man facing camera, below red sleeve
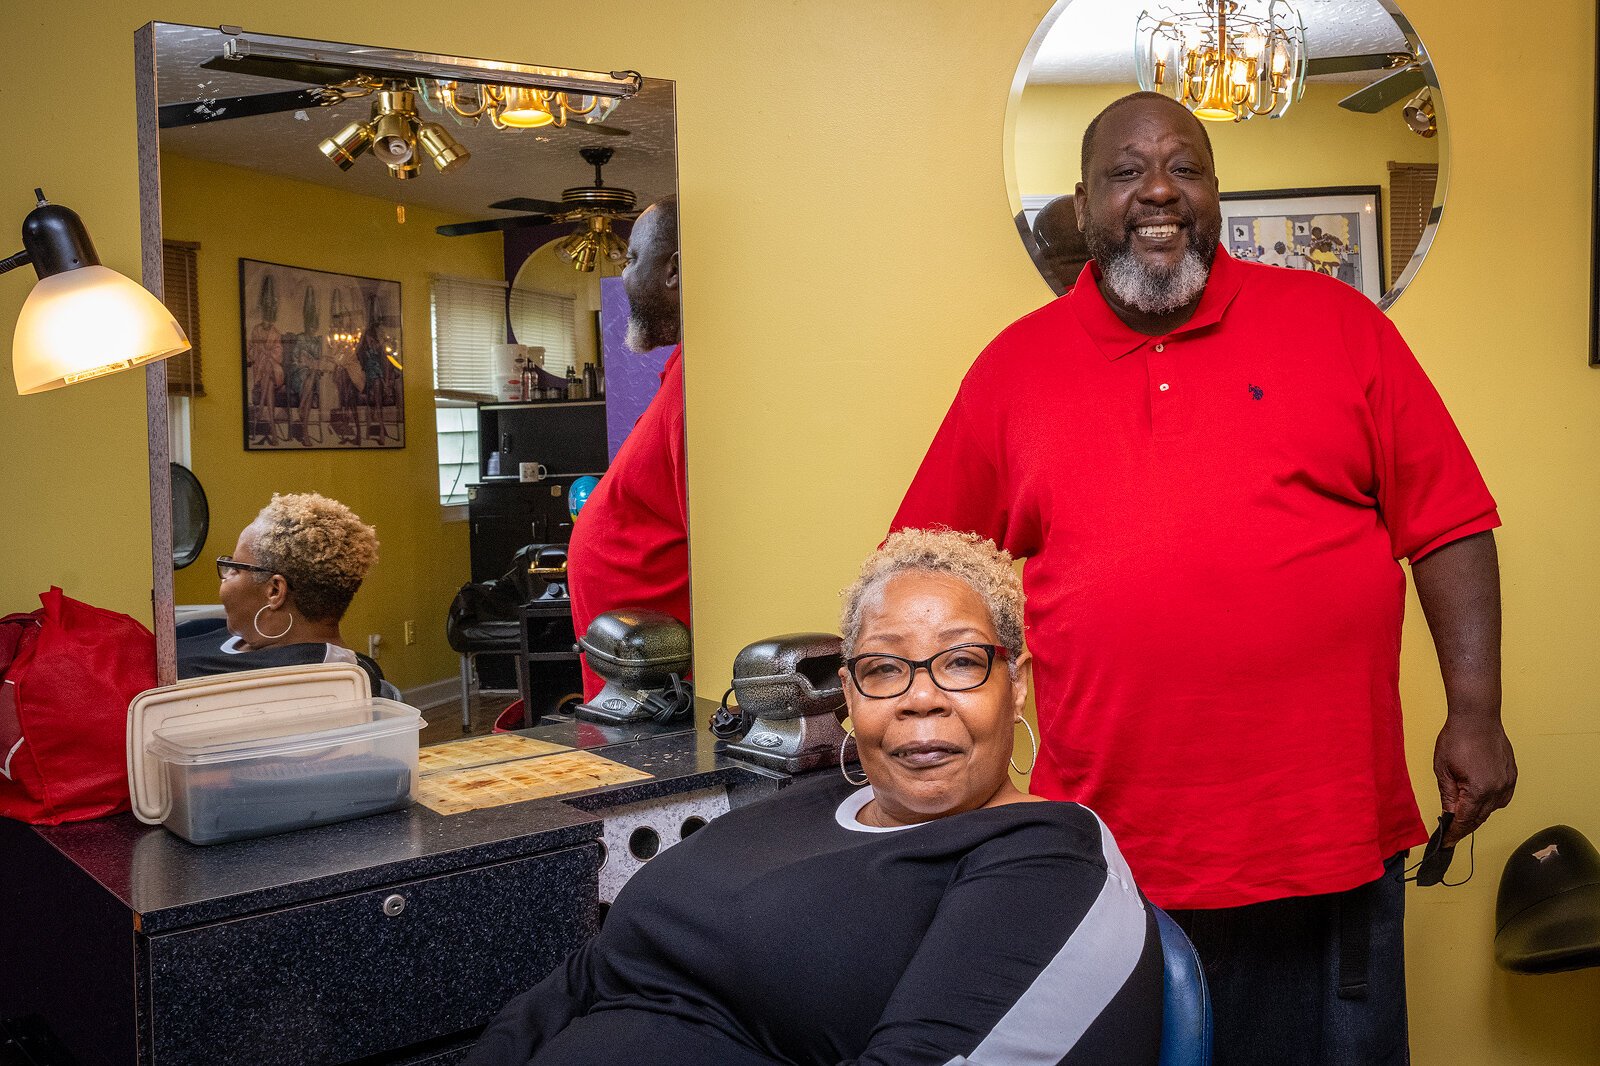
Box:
[1411,533,1517,847]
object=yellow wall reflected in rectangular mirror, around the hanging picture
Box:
[162,154,506,688]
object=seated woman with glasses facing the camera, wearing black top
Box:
[466,530,1162,1066]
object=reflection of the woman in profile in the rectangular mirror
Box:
[178,493,394,696]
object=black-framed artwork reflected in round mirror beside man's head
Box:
[1222,186,1386,303]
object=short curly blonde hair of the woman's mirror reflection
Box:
[248,493,378,621]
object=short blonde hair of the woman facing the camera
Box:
[838,530,1022,669]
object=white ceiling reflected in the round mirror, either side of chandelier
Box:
[1027,0,1408,85]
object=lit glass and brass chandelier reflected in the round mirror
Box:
[1133,0,1306,122]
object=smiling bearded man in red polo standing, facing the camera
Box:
[894,93,1517,1066]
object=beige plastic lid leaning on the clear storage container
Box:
[128,663,371,826]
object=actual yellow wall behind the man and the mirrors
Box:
[0,0,1600,1066]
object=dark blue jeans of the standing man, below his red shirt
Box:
[1170,852,1411,1066]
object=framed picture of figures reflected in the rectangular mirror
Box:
[238,259,405,451]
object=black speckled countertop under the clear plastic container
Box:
[25,713,784,933]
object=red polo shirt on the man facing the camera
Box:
[894,250,1499,908]
